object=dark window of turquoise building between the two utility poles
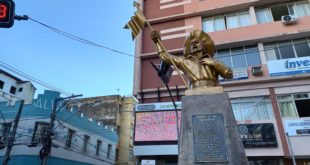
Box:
[32,122,49,144]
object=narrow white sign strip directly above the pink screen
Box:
[136,102,182,112]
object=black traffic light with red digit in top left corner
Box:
[0,0,15,28]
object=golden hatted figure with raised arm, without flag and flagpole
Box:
[151,30,233,92]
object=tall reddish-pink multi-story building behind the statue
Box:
[134,0,310,165]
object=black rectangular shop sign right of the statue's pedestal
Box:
[239,123,278,148]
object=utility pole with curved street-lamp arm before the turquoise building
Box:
[40,95,82,165]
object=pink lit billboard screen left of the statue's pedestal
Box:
[134,110,181,144]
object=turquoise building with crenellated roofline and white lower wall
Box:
[0,91,118,165]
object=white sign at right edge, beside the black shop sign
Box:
[284,120,310,136]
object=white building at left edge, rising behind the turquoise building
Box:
[0,69,36,104]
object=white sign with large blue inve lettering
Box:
[267,57,310,76]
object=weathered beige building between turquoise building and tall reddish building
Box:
[70,95,137,165]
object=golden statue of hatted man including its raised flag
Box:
[124,2,233,95]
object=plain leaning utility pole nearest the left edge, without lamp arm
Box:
[3,100,24,165]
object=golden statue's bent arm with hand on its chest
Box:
[200,58,233,79]
